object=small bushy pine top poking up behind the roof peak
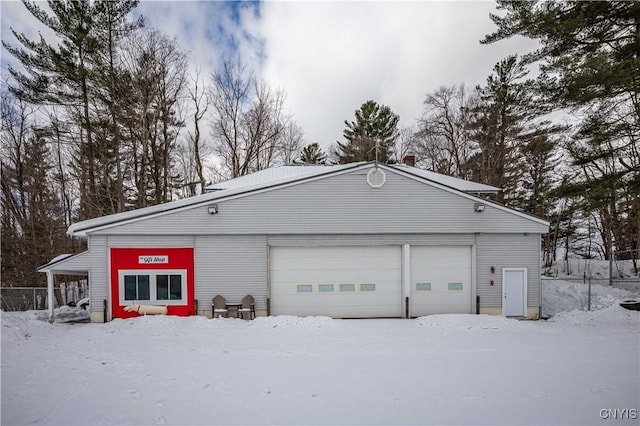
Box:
[335,100,400,164]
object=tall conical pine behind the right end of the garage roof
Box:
[468,55,563,226]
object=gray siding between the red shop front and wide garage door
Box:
[195,235,268,310]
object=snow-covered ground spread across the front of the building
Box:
[1,281,640,425]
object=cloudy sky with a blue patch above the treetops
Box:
[0,0,535,148]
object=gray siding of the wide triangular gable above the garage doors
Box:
[93,171,546,235]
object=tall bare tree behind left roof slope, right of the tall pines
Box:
[123,30,187,207]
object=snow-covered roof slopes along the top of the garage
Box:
[67,162,499,236]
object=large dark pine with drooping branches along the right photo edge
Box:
[481,0,640,258]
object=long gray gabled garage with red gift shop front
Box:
[40,163,548,321]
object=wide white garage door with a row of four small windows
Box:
[269,247,402,318]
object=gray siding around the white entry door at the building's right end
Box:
[476,234,540,308]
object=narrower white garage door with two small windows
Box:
[410,246,472,317]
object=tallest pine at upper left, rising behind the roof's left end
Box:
[2,0,141,219]
